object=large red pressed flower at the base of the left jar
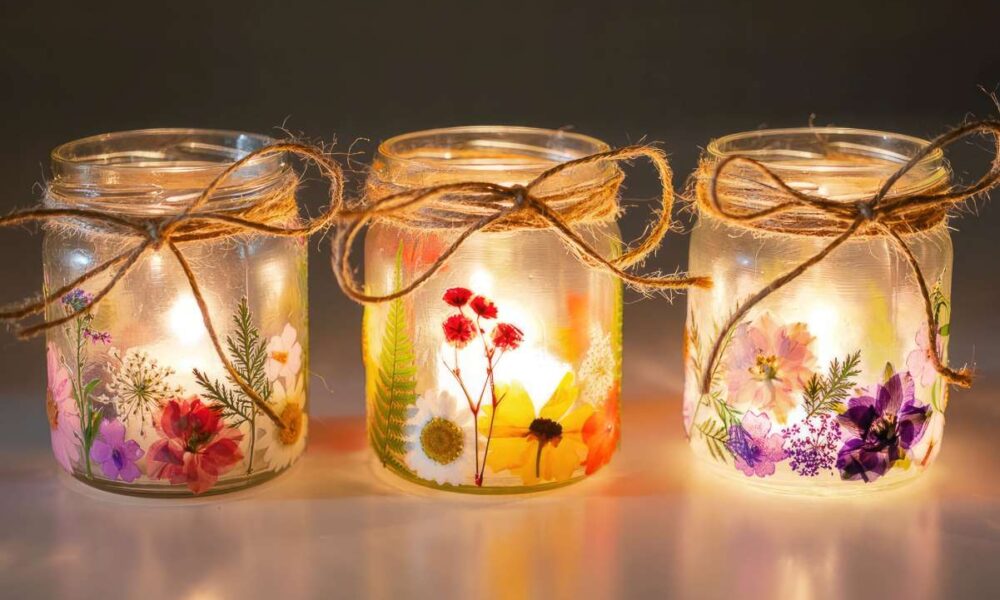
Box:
[146,396,243,494]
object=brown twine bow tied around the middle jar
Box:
[333,146,711,304]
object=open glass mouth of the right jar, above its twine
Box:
[707,127,950,201]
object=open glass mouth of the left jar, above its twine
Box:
[47,128,292,214]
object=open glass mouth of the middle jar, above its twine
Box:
[376,125,610,186]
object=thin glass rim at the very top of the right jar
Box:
[706,127,944,173]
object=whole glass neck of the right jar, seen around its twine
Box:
[696,127,950,236]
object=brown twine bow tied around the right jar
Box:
[697,120,1000,394]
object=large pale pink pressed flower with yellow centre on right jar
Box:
[725,313,816,423]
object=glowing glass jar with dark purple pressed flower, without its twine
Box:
[684,128,952,494]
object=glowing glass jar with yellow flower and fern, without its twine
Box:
[362,127,622,493]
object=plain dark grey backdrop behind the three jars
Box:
[0,0,1000,449]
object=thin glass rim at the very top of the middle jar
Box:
[378,125,610,172]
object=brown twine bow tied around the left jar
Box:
[0,142,344,429]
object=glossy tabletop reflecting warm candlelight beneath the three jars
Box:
[0,392,1000,600]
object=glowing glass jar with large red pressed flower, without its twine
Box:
[44,129,308,496]
